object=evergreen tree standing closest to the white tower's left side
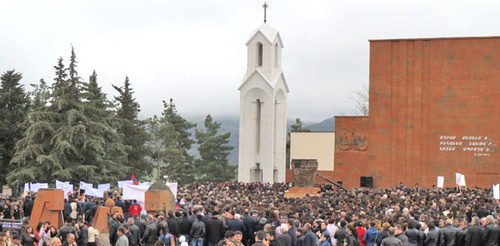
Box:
[195,115,236,182]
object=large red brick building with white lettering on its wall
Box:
[288,37,500,188]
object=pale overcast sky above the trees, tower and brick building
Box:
[0,0,500,121]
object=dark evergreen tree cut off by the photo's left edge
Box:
[0,70,30,184]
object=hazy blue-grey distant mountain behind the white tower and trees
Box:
[186,115,335,165]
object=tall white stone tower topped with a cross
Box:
[238,8,288,183]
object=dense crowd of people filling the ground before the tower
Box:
[0,182,500,246]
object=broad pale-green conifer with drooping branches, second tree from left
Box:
[7,57,71,182]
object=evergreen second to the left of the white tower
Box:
[154,99,196,184]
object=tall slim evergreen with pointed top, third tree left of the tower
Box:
[113,76,153,178]
